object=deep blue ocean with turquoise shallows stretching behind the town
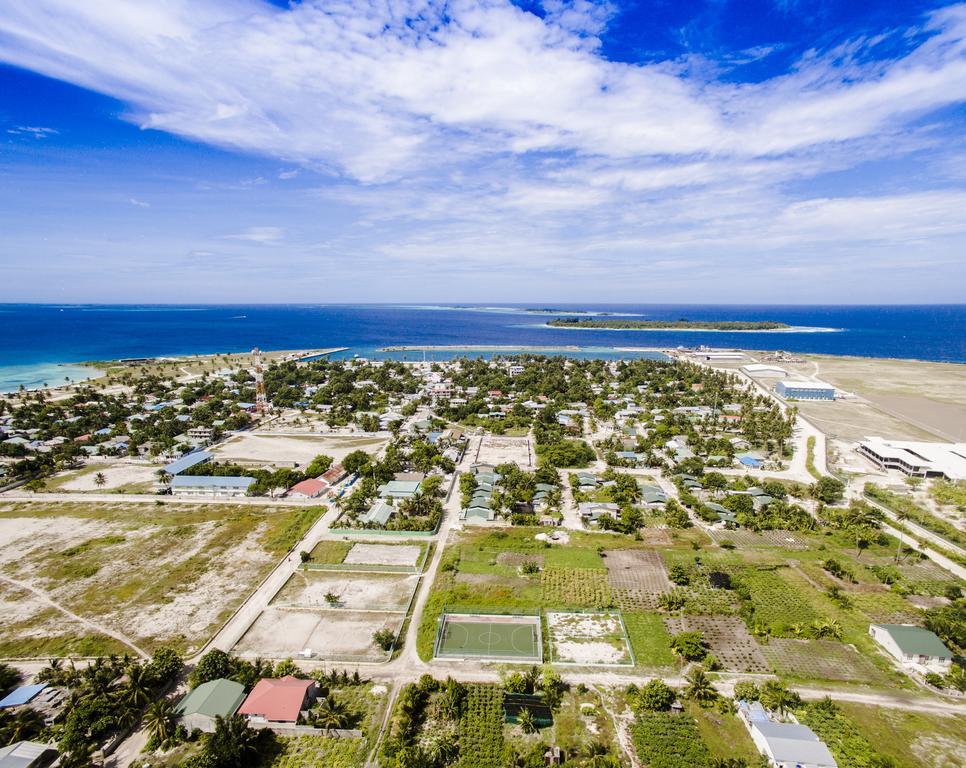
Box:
[0,304,966,391]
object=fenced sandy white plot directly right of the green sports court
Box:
[547,612,634,666]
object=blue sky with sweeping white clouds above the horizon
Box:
[0,0,966,303]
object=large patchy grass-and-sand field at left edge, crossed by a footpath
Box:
[0,502,318,655]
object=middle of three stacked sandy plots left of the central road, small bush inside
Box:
[273,571,419,611]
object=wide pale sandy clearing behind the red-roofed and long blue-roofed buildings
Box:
[213,432,386,466]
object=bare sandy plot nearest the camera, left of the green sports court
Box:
[232,606,405,661]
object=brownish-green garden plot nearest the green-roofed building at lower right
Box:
[761,638,889,685]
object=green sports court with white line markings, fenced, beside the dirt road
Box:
[434,614,543,663]
